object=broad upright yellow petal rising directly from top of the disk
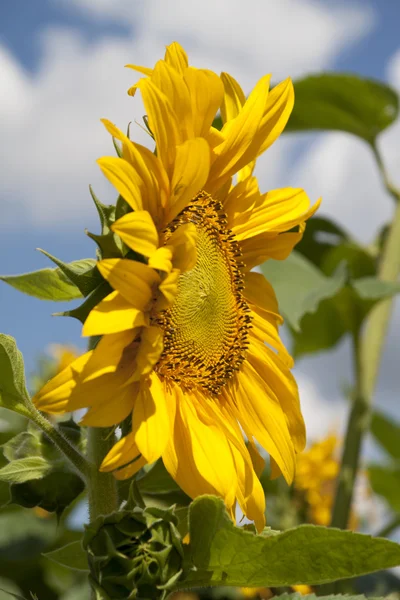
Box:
[167,138,210,221]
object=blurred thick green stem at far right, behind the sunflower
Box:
[331,149,400,529]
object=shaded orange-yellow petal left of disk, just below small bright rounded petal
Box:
[97,258,160,308]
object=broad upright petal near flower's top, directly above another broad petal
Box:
[183,68,224,137]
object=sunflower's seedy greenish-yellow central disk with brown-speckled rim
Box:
[156,192,250,394]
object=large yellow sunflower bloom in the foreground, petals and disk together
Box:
[34,43,318,530]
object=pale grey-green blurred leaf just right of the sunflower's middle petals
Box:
[261,252,346,331]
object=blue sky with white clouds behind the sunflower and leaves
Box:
[0,0,400,450]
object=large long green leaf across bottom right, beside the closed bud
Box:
[186,496,400,587]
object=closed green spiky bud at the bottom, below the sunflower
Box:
[83,507,183,600]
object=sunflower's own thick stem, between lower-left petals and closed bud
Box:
[88,427,118,521]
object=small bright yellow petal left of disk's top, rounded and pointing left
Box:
[111,210,158,256]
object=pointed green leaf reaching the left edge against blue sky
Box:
[0,261,86,302]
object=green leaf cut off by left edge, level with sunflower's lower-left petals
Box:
[0,333,30,416]
